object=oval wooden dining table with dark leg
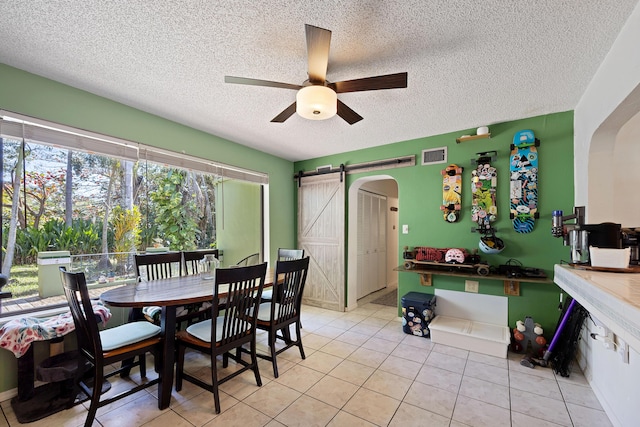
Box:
[100,269,273,409]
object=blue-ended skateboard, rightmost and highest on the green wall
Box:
[509,130,540,233]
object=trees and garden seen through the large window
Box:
[0,139,220,299]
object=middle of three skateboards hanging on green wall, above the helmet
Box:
[471,151,498,232]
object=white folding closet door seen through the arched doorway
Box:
[357,190,387,298]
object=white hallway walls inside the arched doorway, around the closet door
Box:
[346,175,398,311]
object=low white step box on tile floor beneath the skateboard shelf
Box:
[429,315,511,358]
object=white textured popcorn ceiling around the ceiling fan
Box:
[0,0,637,160]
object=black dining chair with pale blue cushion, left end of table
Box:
[60,267,162,427]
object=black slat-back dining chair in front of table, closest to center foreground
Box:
[176,263,267,414]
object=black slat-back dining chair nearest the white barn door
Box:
[256,257,309,378]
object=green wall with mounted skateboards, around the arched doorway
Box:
[295,112,573,338]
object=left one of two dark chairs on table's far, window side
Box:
[134,252,209,329]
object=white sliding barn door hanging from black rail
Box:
[298,173,345,311]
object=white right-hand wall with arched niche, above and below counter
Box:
[574,5,640,426]
